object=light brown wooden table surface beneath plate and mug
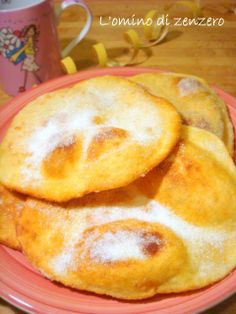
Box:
[0,0,236,314]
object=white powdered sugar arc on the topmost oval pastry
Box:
[21,94,162,185]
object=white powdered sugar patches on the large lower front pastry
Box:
[43,189,229,276]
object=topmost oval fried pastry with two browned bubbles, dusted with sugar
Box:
[0,76,181,202]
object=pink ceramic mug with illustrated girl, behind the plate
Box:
[0,0,92,95]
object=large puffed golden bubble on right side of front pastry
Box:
[137,127,236,226]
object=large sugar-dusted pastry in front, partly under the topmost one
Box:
[17,127,236,299]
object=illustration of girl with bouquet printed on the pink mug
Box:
[0,24,41,92]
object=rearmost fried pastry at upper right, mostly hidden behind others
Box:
[130,73,234,156]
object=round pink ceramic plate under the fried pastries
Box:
[0,68,236,314]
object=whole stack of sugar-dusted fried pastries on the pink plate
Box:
[0,73,236,300]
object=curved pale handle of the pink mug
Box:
[58,0,93,58]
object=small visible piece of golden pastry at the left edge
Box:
[0,184,25,250]
